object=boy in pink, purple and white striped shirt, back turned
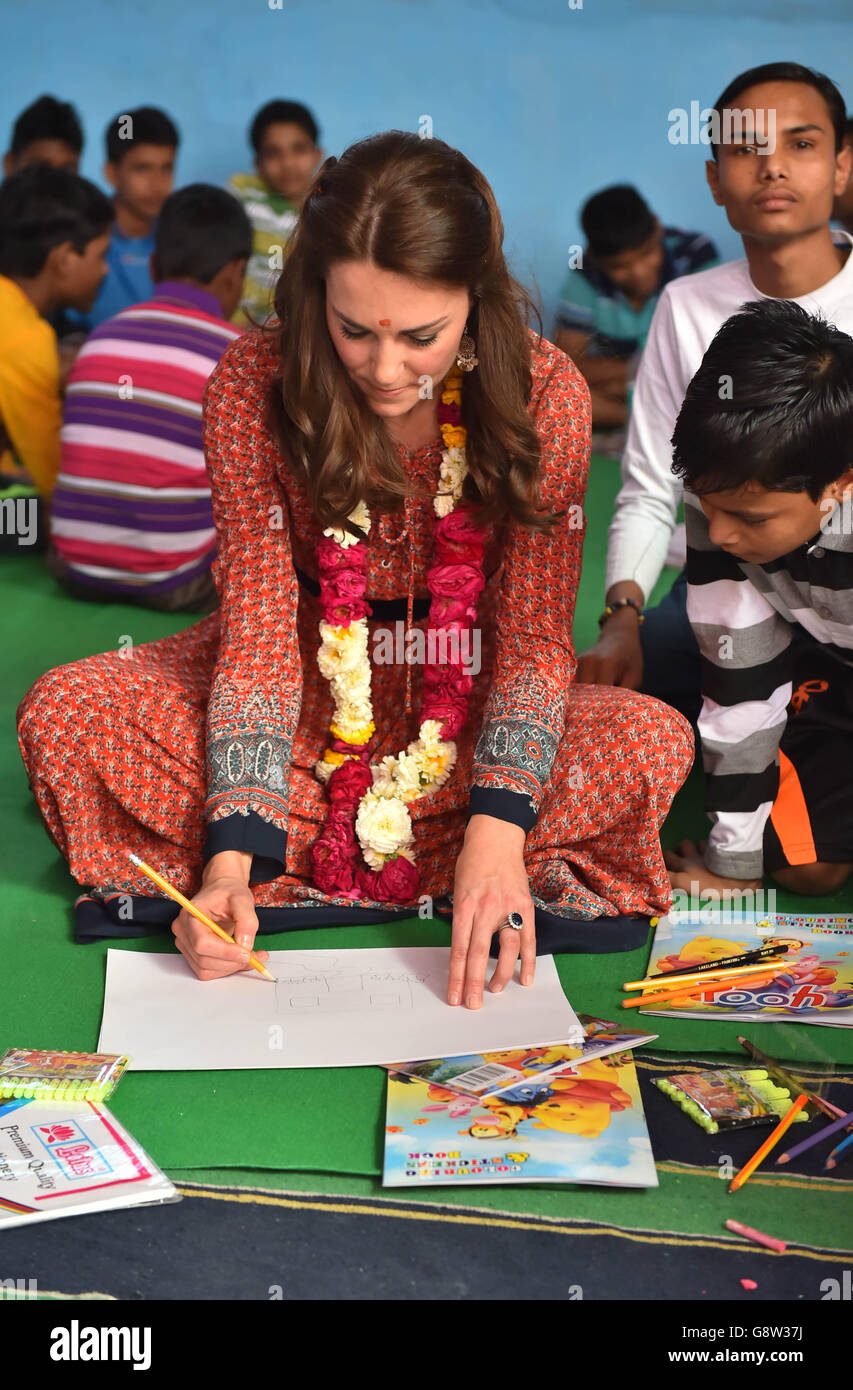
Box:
[47,183,251,613]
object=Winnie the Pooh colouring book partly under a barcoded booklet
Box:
[382,1054,657,1187]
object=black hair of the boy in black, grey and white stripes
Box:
[672,299,853,502]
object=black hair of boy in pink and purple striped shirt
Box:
[154,183,251,285]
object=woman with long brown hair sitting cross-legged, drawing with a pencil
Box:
[19,131,692,1008]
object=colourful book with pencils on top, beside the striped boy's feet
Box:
[640,912,853,1029]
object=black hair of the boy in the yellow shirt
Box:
[0,164,115,279]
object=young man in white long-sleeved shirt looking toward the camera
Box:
[578,63,853,739]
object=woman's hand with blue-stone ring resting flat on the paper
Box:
[447,816,536,1009]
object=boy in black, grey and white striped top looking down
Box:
[667,299,853,895]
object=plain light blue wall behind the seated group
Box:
[0,0,853,332]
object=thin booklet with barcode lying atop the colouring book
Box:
[386,1013,657,1097]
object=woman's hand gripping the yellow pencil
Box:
[172,866,270,980]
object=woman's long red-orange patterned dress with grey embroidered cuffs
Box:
[19,334,692,934]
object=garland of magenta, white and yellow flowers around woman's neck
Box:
[311,367,486,902]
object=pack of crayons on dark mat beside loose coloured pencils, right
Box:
[654,1066,809,1134]
